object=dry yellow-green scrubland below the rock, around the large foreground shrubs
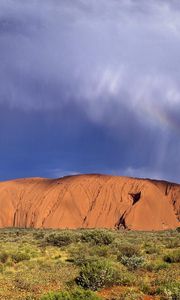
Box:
[0,229,180,300]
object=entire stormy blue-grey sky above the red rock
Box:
[0,0,180,183]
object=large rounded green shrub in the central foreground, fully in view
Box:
[76,260,118,291]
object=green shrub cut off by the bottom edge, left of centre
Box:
[40,289,101,300]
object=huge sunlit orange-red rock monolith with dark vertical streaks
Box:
[0,174,180,230]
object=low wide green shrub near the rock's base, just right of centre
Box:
[81,229,114,245]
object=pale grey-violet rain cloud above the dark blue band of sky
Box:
[0,0,180,180]
